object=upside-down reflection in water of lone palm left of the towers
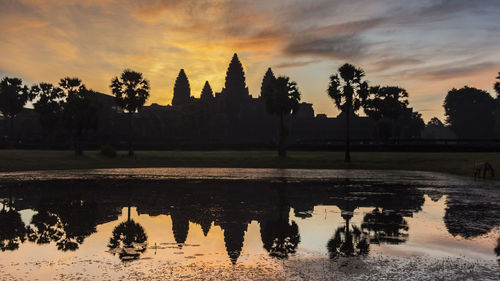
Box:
[108,206,148,261]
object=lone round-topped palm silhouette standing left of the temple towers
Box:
[110,69,149,156]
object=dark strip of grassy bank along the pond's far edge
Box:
[0,150,500,176]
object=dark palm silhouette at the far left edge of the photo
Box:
[0,77,29,138]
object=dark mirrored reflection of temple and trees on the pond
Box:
[0,177,500,264]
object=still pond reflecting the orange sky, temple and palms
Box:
[0,168,500,280]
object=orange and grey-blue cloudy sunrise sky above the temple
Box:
[0,0,500,121]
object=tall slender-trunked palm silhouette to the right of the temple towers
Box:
[328,63,368,162]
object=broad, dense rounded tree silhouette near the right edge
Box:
[443,86,496,138]
